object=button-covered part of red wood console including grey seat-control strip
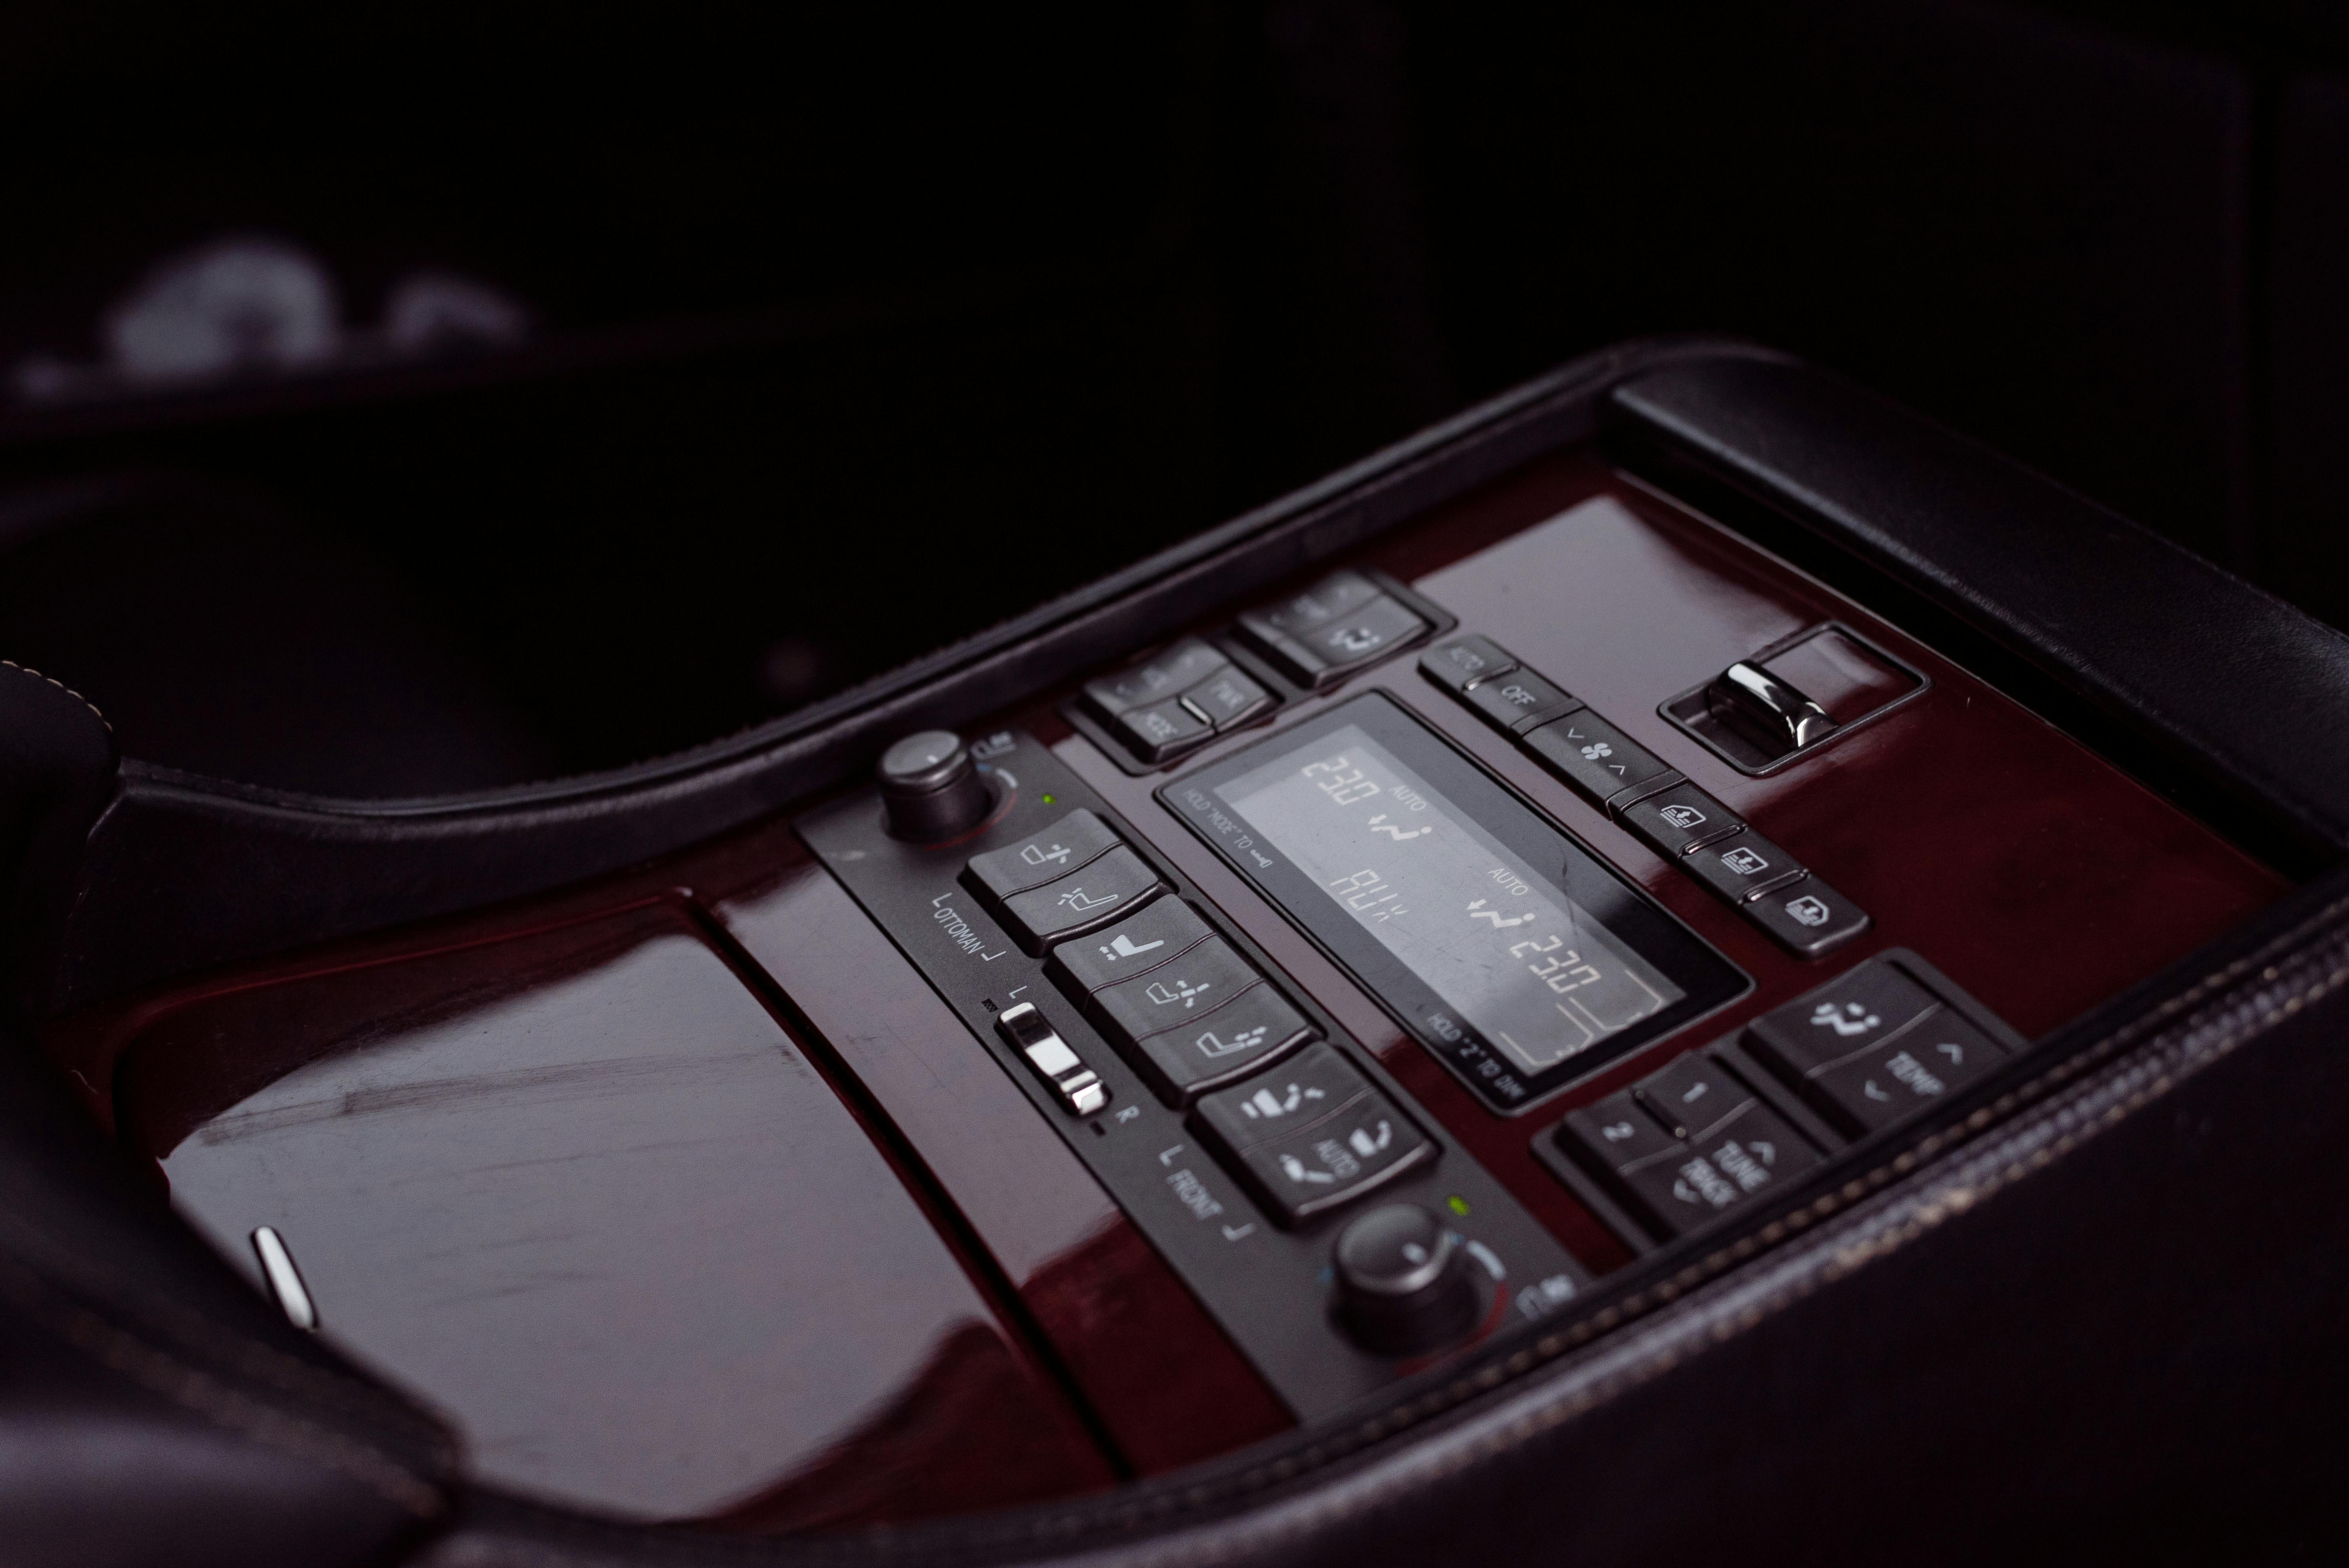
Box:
[799,443,2279,1420]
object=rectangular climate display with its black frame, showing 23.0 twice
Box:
[1163,697,1745,1110]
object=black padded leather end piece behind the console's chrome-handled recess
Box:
[1609,357,2349,857]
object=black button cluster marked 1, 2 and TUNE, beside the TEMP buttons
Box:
[1555,1052,1821,1240]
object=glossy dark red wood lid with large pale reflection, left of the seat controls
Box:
[120,902,1109,1523]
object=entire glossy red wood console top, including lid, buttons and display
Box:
[32,342,2290,1528]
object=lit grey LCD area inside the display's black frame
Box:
[1214,725,1686,1073]
